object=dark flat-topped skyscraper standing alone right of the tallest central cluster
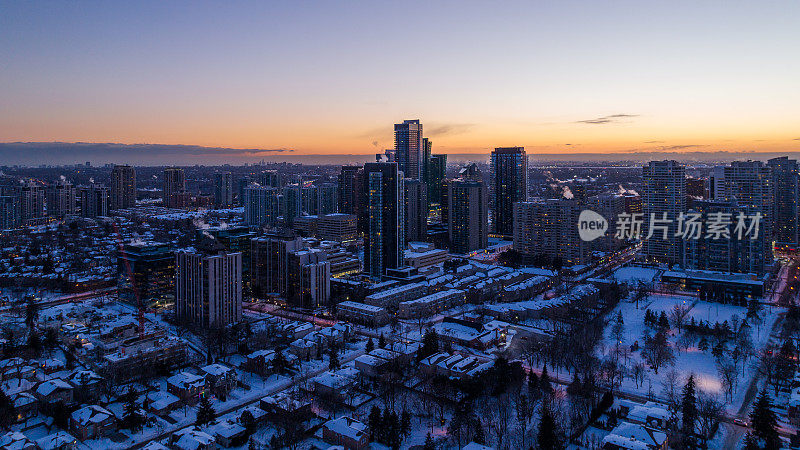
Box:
[490,147,528,236]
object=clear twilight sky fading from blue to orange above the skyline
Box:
[0,0,800,163]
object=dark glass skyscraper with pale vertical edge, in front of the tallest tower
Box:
[364,162,405,280]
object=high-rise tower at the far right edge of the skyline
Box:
[767,156,800,244]
